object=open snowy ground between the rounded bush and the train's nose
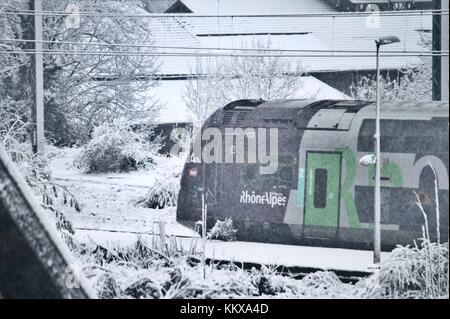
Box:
[50,149,189,235]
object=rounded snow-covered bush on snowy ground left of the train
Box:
[75,119,159,173]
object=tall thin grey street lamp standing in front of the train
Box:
[373,36,400,265]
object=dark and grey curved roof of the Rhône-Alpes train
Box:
[205,99,449,129]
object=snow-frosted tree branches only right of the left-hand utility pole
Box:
[44,0,162,140]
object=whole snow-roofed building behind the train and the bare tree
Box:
[139,0,438,127]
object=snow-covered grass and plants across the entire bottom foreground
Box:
[67,232,448,298]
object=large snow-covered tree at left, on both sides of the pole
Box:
[0,0,159,143]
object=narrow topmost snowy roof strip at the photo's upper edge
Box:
[174,0,334,15]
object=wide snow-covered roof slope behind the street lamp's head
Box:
[173,13,432,72]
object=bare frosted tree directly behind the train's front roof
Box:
[183,41,305,124]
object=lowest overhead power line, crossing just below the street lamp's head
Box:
[0,38,449,54]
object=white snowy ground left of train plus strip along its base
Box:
[51,149,388,272]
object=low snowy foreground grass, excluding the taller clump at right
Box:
[71,235,365,298]
